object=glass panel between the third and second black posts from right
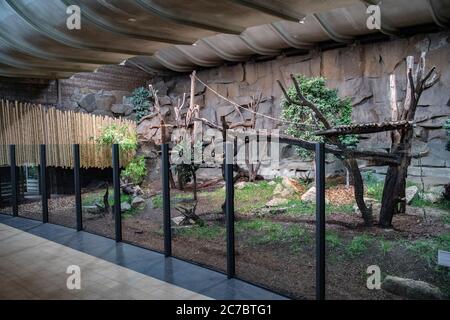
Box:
[170,165,226,271]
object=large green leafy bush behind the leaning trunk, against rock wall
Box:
[281,75,358,159]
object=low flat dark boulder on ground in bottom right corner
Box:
[381,276,444,300]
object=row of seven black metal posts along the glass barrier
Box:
[2,143,325,300]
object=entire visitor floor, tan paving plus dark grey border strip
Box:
[0,214,284,300]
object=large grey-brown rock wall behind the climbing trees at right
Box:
[141,32,450,185]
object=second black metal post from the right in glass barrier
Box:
[224,142,235,279]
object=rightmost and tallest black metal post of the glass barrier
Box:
[316,143,325,300]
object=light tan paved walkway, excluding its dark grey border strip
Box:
[0,224,209,300]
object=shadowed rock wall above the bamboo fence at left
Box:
[0,65,148,119]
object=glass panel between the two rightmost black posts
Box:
[235,145,315,299]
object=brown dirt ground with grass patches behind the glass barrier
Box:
[1,182,450,299]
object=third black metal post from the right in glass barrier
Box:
[161,143,172,257]
